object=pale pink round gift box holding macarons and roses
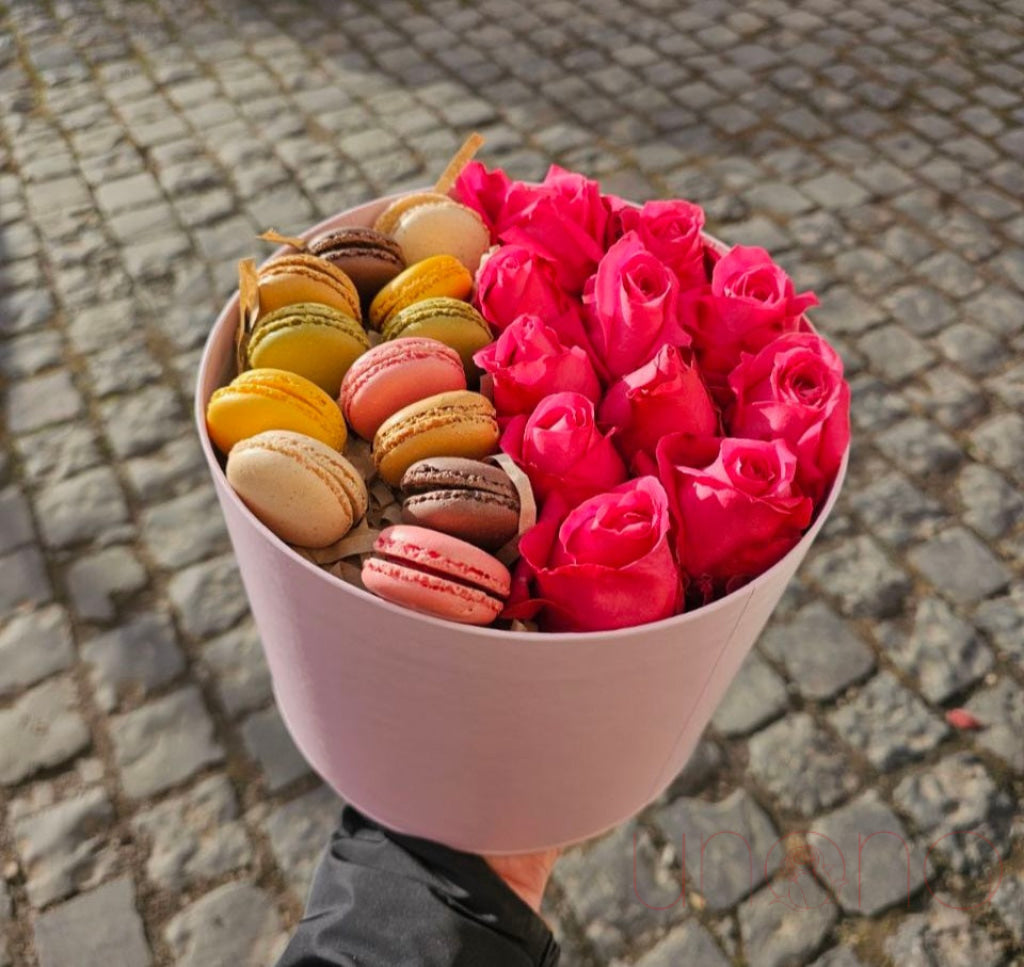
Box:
[196,190,849,853]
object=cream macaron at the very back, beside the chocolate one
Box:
[374,192,490,275]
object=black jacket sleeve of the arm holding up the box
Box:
[276,806,559,967]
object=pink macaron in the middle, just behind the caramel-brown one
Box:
[338,337,466,440]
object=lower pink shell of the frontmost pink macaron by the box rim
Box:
[362,557,504,626]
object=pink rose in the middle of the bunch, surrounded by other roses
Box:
[598,345,718,463]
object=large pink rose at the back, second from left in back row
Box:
[498,165,608,295]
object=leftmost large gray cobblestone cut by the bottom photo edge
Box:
[35,877,153,967]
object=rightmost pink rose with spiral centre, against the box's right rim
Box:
[729,333,850,502]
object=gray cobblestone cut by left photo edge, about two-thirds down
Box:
[0,604,75,697]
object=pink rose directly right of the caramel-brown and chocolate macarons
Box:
[501,392,627,507]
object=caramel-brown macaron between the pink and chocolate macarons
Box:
[373,390,500,487]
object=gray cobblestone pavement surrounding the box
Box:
[0,0,1024,967]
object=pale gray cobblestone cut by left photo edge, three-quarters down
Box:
[0,678,89,784]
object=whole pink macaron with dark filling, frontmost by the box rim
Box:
[362,523,512,625]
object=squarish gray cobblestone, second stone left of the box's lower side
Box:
[110,685,224,799]
